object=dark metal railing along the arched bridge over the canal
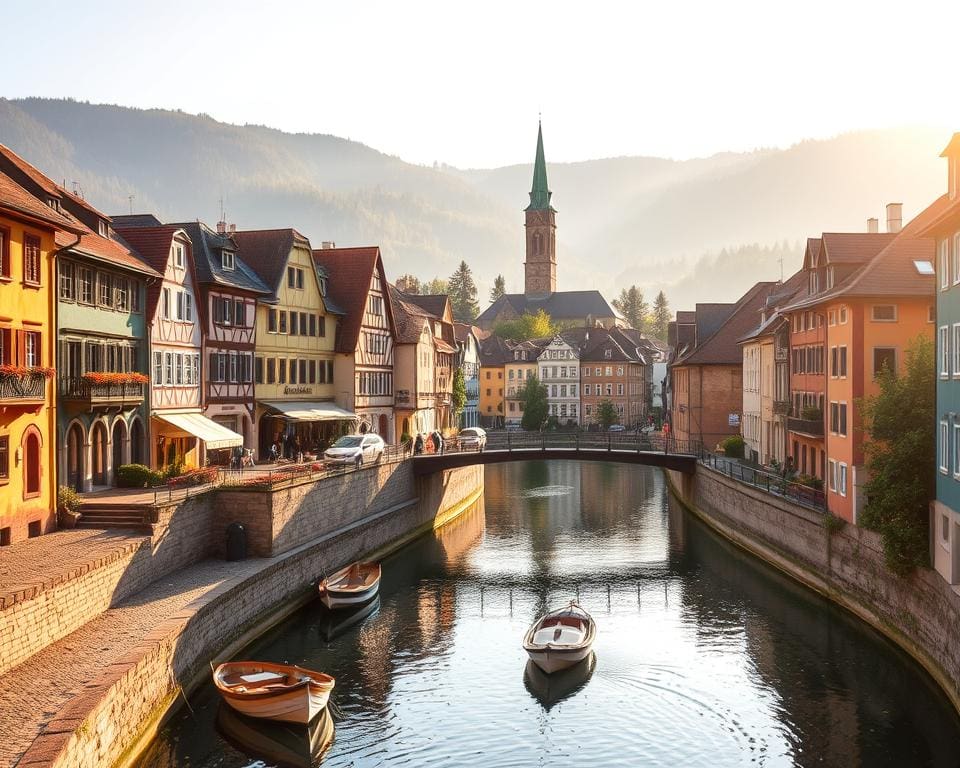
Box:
[444,431,702,457]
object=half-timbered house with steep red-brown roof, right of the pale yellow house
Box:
[313,246,394,443]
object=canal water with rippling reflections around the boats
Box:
[140,462,960,768]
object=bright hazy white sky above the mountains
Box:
[0,0,960,167]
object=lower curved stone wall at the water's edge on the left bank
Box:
[19,467,483,768]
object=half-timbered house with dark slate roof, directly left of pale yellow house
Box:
[179,222,271,464]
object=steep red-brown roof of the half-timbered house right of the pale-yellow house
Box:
[313,245,396,354]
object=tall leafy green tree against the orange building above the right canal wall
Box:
[860,336,937,576]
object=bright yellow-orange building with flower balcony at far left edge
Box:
[0,167,80,545]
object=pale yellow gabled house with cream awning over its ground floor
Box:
[233,229,356,459]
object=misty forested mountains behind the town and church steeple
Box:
[0,99,949,309]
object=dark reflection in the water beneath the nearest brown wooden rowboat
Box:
[217,704,334,768]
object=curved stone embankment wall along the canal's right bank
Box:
[667,466,960,711]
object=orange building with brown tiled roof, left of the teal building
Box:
[788,207,944,523]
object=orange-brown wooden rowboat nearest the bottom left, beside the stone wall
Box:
[213,661,334,725]
